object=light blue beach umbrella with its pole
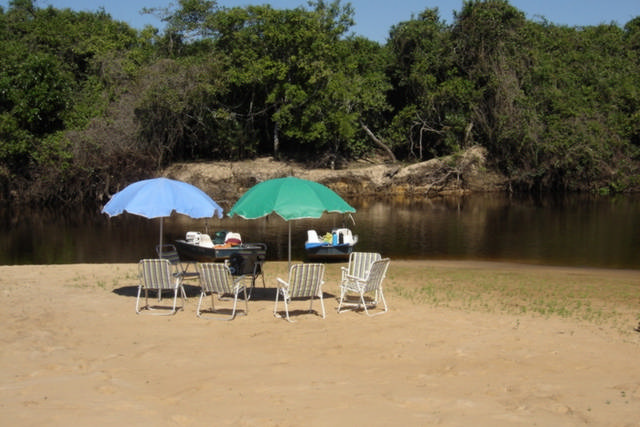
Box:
[102,178,222,254]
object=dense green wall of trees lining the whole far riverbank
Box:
[0,0,640,203]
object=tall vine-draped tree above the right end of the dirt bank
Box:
[452,0,540,187]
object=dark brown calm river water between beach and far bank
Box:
[0,194,640,269]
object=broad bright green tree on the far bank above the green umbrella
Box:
[210,1,360,160]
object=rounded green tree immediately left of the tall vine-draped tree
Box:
[387,9,475,160]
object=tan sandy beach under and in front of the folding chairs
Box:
[0,261,640,426]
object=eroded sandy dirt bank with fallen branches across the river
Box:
[165,147,506,209]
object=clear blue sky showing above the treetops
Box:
[5,0,640,43]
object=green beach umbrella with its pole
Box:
[228,176,356,264]
